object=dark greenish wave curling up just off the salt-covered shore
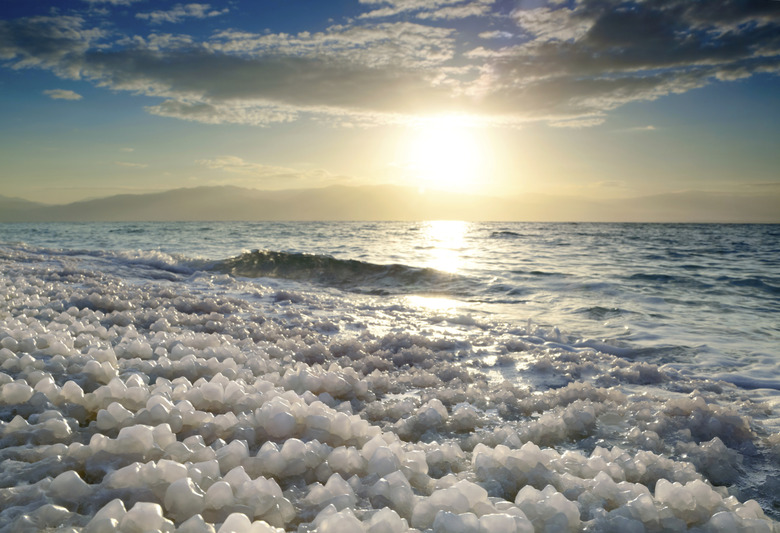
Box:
[210,250,468,294]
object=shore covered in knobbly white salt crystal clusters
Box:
[0,247,780,533]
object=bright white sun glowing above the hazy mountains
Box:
[404,116,486,192]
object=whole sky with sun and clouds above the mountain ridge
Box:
[0,0,780,216]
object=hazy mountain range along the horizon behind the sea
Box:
[0,185,780,223]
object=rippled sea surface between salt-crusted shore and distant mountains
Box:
[0,221,780,389]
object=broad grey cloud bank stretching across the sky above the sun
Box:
[0,0,780,127]
